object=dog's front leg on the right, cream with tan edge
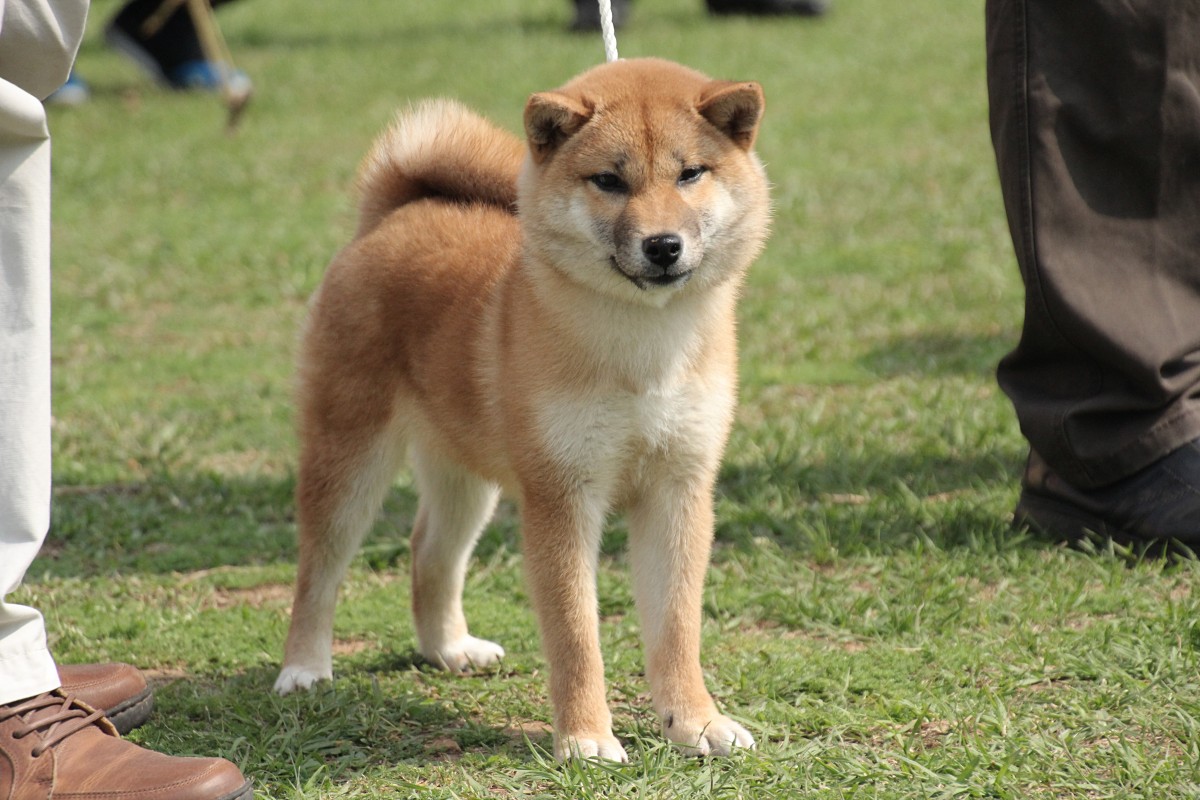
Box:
[629,480,754,756]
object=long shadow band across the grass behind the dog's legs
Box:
[44,434,1021,578]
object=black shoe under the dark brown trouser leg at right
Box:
[1013,439,1200,549]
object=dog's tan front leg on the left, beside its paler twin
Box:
[522,493,629,762]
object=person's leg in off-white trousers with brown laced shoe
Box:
[0,7,252,800]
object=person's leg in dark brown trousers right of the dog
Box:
[986,0,1200,544]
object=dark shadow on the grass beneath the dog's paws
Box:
[136,664,550,796]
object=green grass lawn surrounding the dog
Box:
[16,0,1200,800]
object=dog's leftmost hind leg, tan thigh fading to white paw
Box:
[275,431,403,694]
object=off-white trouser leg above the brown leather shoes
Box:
[0,0,88,703]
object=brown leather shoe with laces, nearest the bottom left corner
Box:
[0,690,251,800]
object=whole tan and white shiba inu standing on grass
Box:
[275,59,769,760]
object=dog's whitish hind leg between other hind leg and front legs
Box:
[413,447,504,672]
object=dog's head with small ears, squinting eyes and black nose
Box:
[518,59,769,307]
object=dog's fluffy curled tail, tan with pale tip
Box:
[358,100,524,236]
